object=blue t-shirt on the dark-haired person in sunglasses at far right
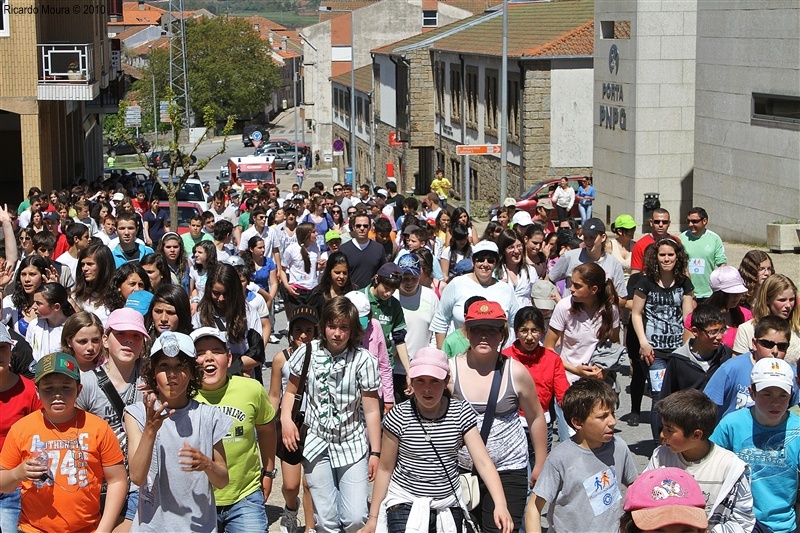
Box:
[703,352,798,418]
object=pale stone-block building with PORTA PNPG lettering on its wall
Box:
[594,0,800,243]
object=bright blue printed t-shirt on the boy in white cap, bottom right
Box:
[711,408,800,531]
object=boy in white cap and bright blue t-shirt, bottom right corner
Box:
[711,357,800,531]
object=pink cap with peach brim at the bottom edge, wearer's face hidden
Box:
[623,467,708,531]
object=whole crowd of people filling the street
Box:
[0,173,800,533]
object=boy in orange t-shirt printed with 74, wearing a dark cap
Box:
[0,352,128,533]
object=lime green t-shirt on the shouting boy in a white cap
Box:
[195,376,275,505]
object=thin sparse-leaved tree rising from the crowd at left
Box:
[106,95,234,228]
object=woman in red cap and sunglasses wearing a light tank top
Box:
[450,301,547,532]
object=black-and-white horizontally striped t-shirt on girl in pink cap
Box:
[383,398,477,499]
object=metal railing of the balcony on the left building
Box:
[37,43,94,83]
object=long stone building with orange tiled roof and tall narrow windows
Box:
[373,0,594,197]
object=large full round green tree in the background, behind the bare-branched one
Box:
[186,17,280,120]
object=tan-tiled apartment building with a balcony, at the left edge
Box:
[0,0,122,204]
